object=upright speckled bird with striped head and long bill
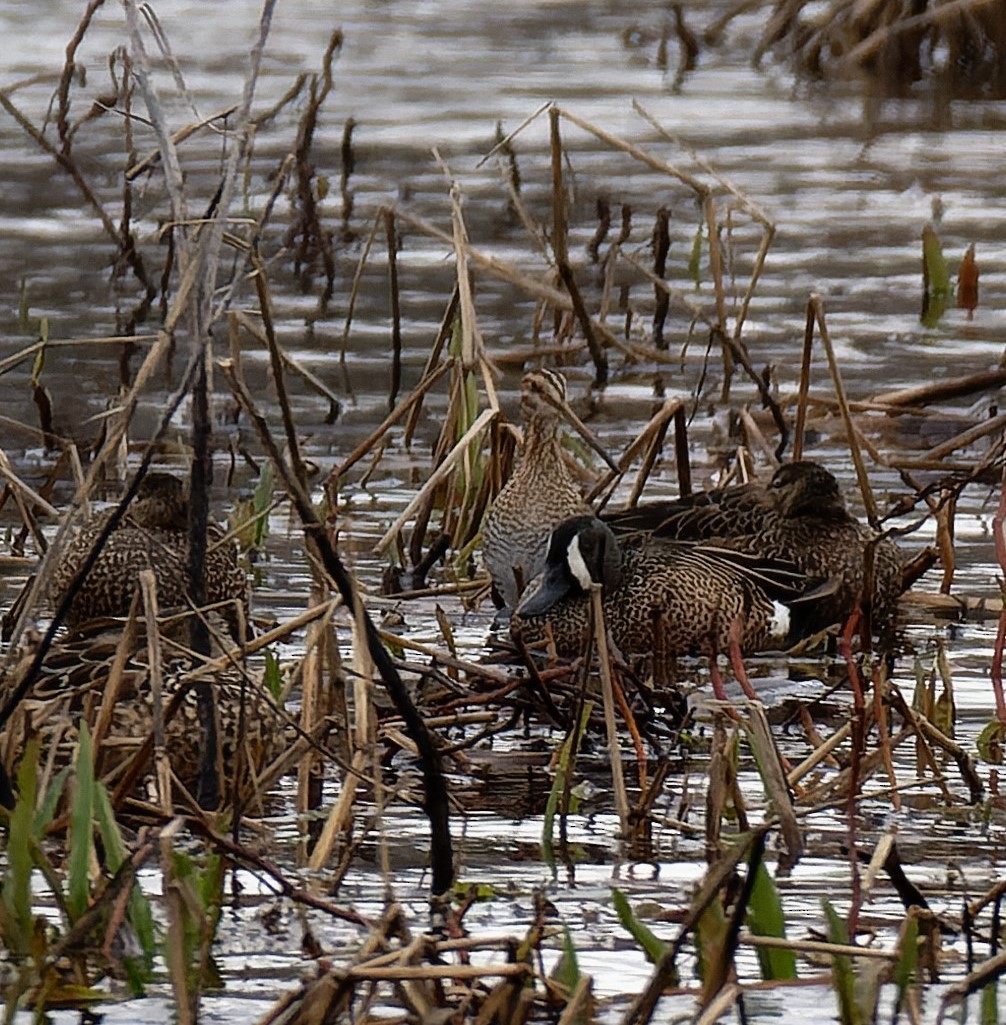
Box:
[482,368,596,610]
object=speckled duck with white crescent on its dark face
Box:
[511,516,817,655]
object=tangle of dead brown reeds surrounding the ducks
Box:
[0,3,1006,1025]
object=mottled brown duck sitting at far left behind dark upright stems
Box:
[48,473,249,637]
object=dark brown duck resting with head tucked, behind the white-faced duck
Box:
[605,460,904,630]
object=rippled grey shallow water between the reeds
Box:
[0,0,1006,1022]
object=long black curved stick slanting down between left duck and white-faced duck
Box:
[220,360,454,897]
